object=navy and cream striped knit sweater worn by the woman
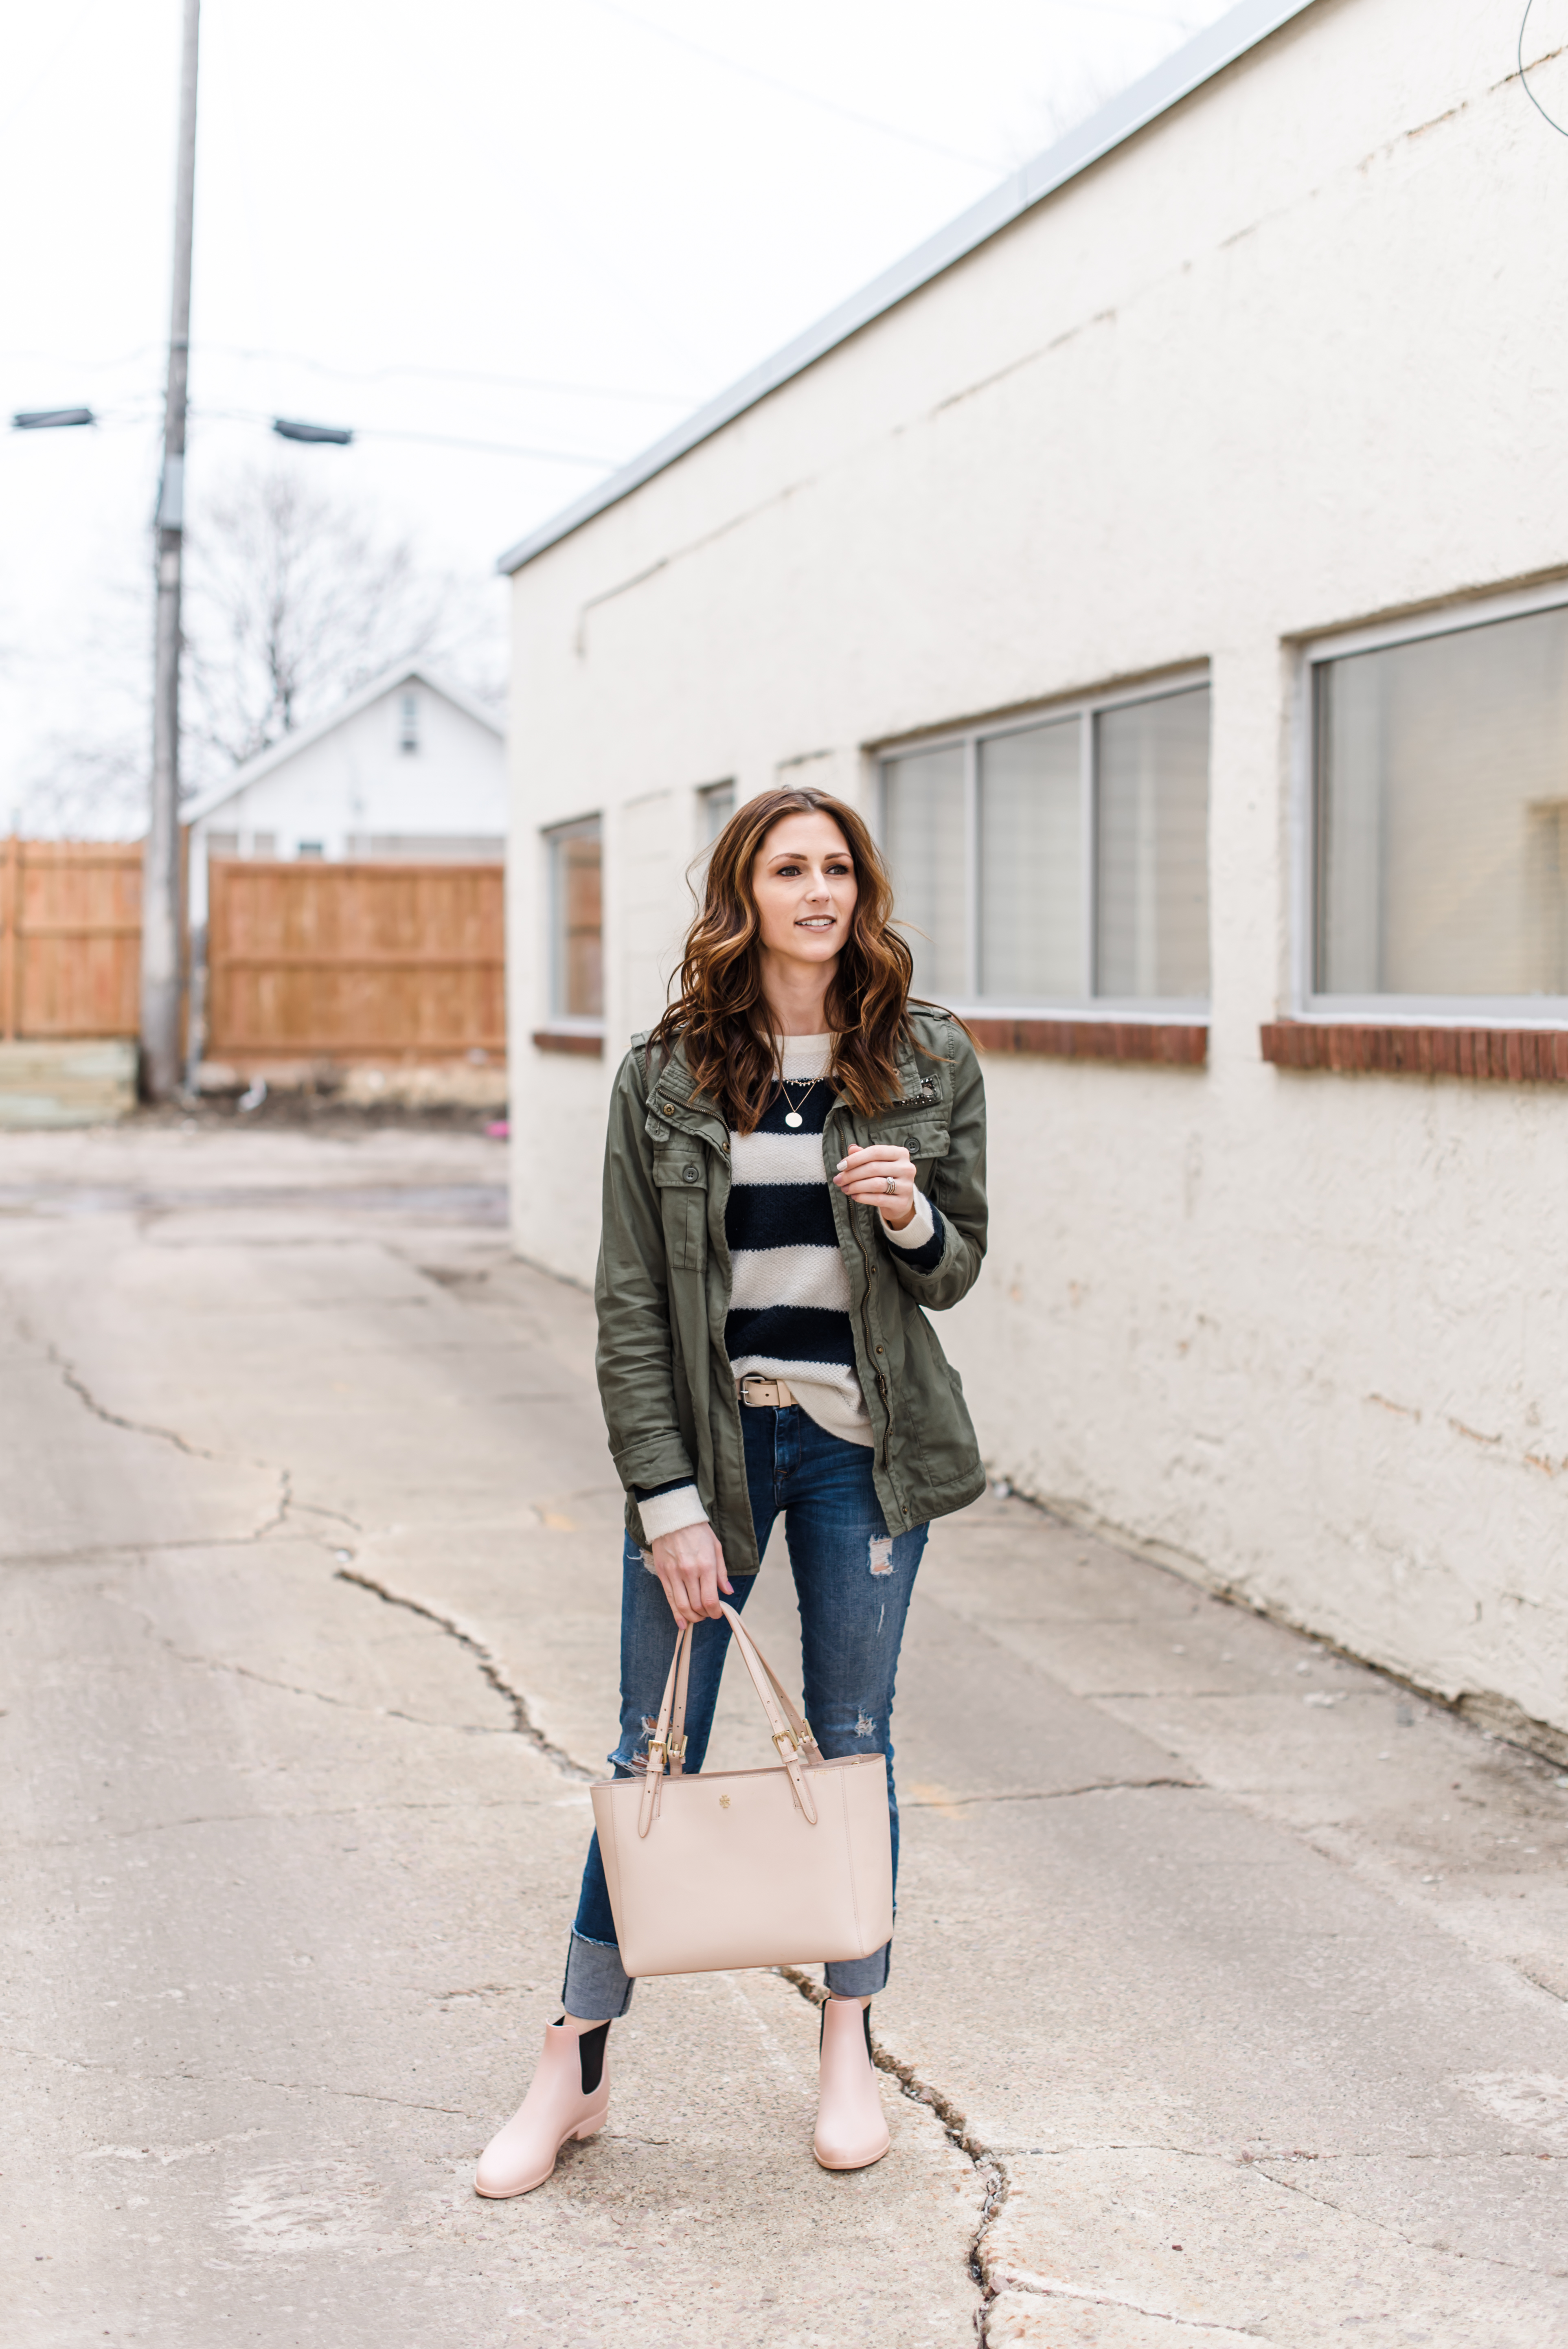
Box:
[638,1036,941,1541]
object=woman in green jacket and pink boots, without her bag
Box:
[474,792,986,2196]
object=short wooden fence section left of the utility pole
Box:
[0,839,141,1043]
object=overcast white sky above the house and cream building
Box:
[0,0,1228,829]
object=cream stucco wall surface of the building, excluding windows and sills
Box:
[512,0,1568,1729]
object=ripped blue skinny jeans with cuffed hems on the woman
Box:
[561,1405,927,2022]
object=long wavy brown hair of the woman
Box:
[650,789,913,1134]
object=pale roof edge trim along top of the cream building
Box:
[495,0,1317,573]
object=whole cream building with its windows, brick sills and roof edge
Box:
[504,0,1568,1750]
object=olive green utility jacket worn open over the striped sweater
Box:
[594,1005,986,1574]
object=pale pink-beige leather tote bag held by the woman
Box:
[592,1600,892,1976]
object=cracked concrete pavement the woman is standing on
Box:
[0,1125,1568,2349]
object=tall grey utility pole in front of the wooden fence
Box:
[141,0,202,1102]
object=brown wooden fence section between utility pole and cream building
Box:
[206,858,507,1059]
